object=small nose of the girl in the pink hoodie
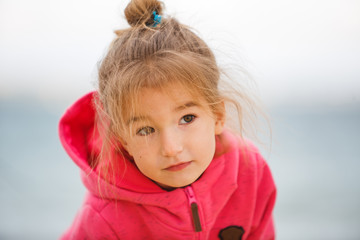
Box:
[161,130,183,157]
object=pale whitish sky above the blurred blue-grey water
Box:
[0,0,360,106]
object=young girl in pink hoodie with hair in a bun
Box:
[59,0,276,240]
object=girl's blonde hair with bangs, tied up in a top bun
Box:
[91,0,262,183]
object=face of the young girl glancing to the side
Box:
[122,84,224,189]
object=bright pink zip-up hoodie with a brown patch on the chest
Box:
[59,93,276,240]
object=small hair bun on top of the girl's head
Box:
[124,0,163,27]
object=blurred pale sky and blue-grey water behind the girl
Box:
[0,0,360,240]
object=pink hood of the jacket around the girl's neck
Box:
[59,92,239,205]
